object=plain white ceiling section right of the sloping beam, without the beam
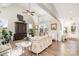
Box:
[54,3,79,19]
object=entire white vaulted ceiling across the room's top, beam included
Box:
[0,3,79,20]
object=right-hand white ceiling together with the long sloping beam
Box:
[38,3,79,19]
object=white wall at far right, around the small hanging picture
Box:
[62,19,79,38]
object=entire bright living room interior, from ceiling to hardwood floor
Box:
[0,3,79,56]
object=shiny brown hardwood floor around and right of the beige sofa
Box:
[12,39,79,56]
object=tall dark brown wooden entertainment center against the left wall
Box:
[14,22,27,40]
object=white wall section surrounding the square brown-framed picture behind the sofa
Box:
[49,18,62,41]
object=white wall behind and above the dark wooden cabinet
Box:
[0,4,32,33]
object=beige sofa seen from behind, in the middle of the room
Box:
[31,35,52,55]
